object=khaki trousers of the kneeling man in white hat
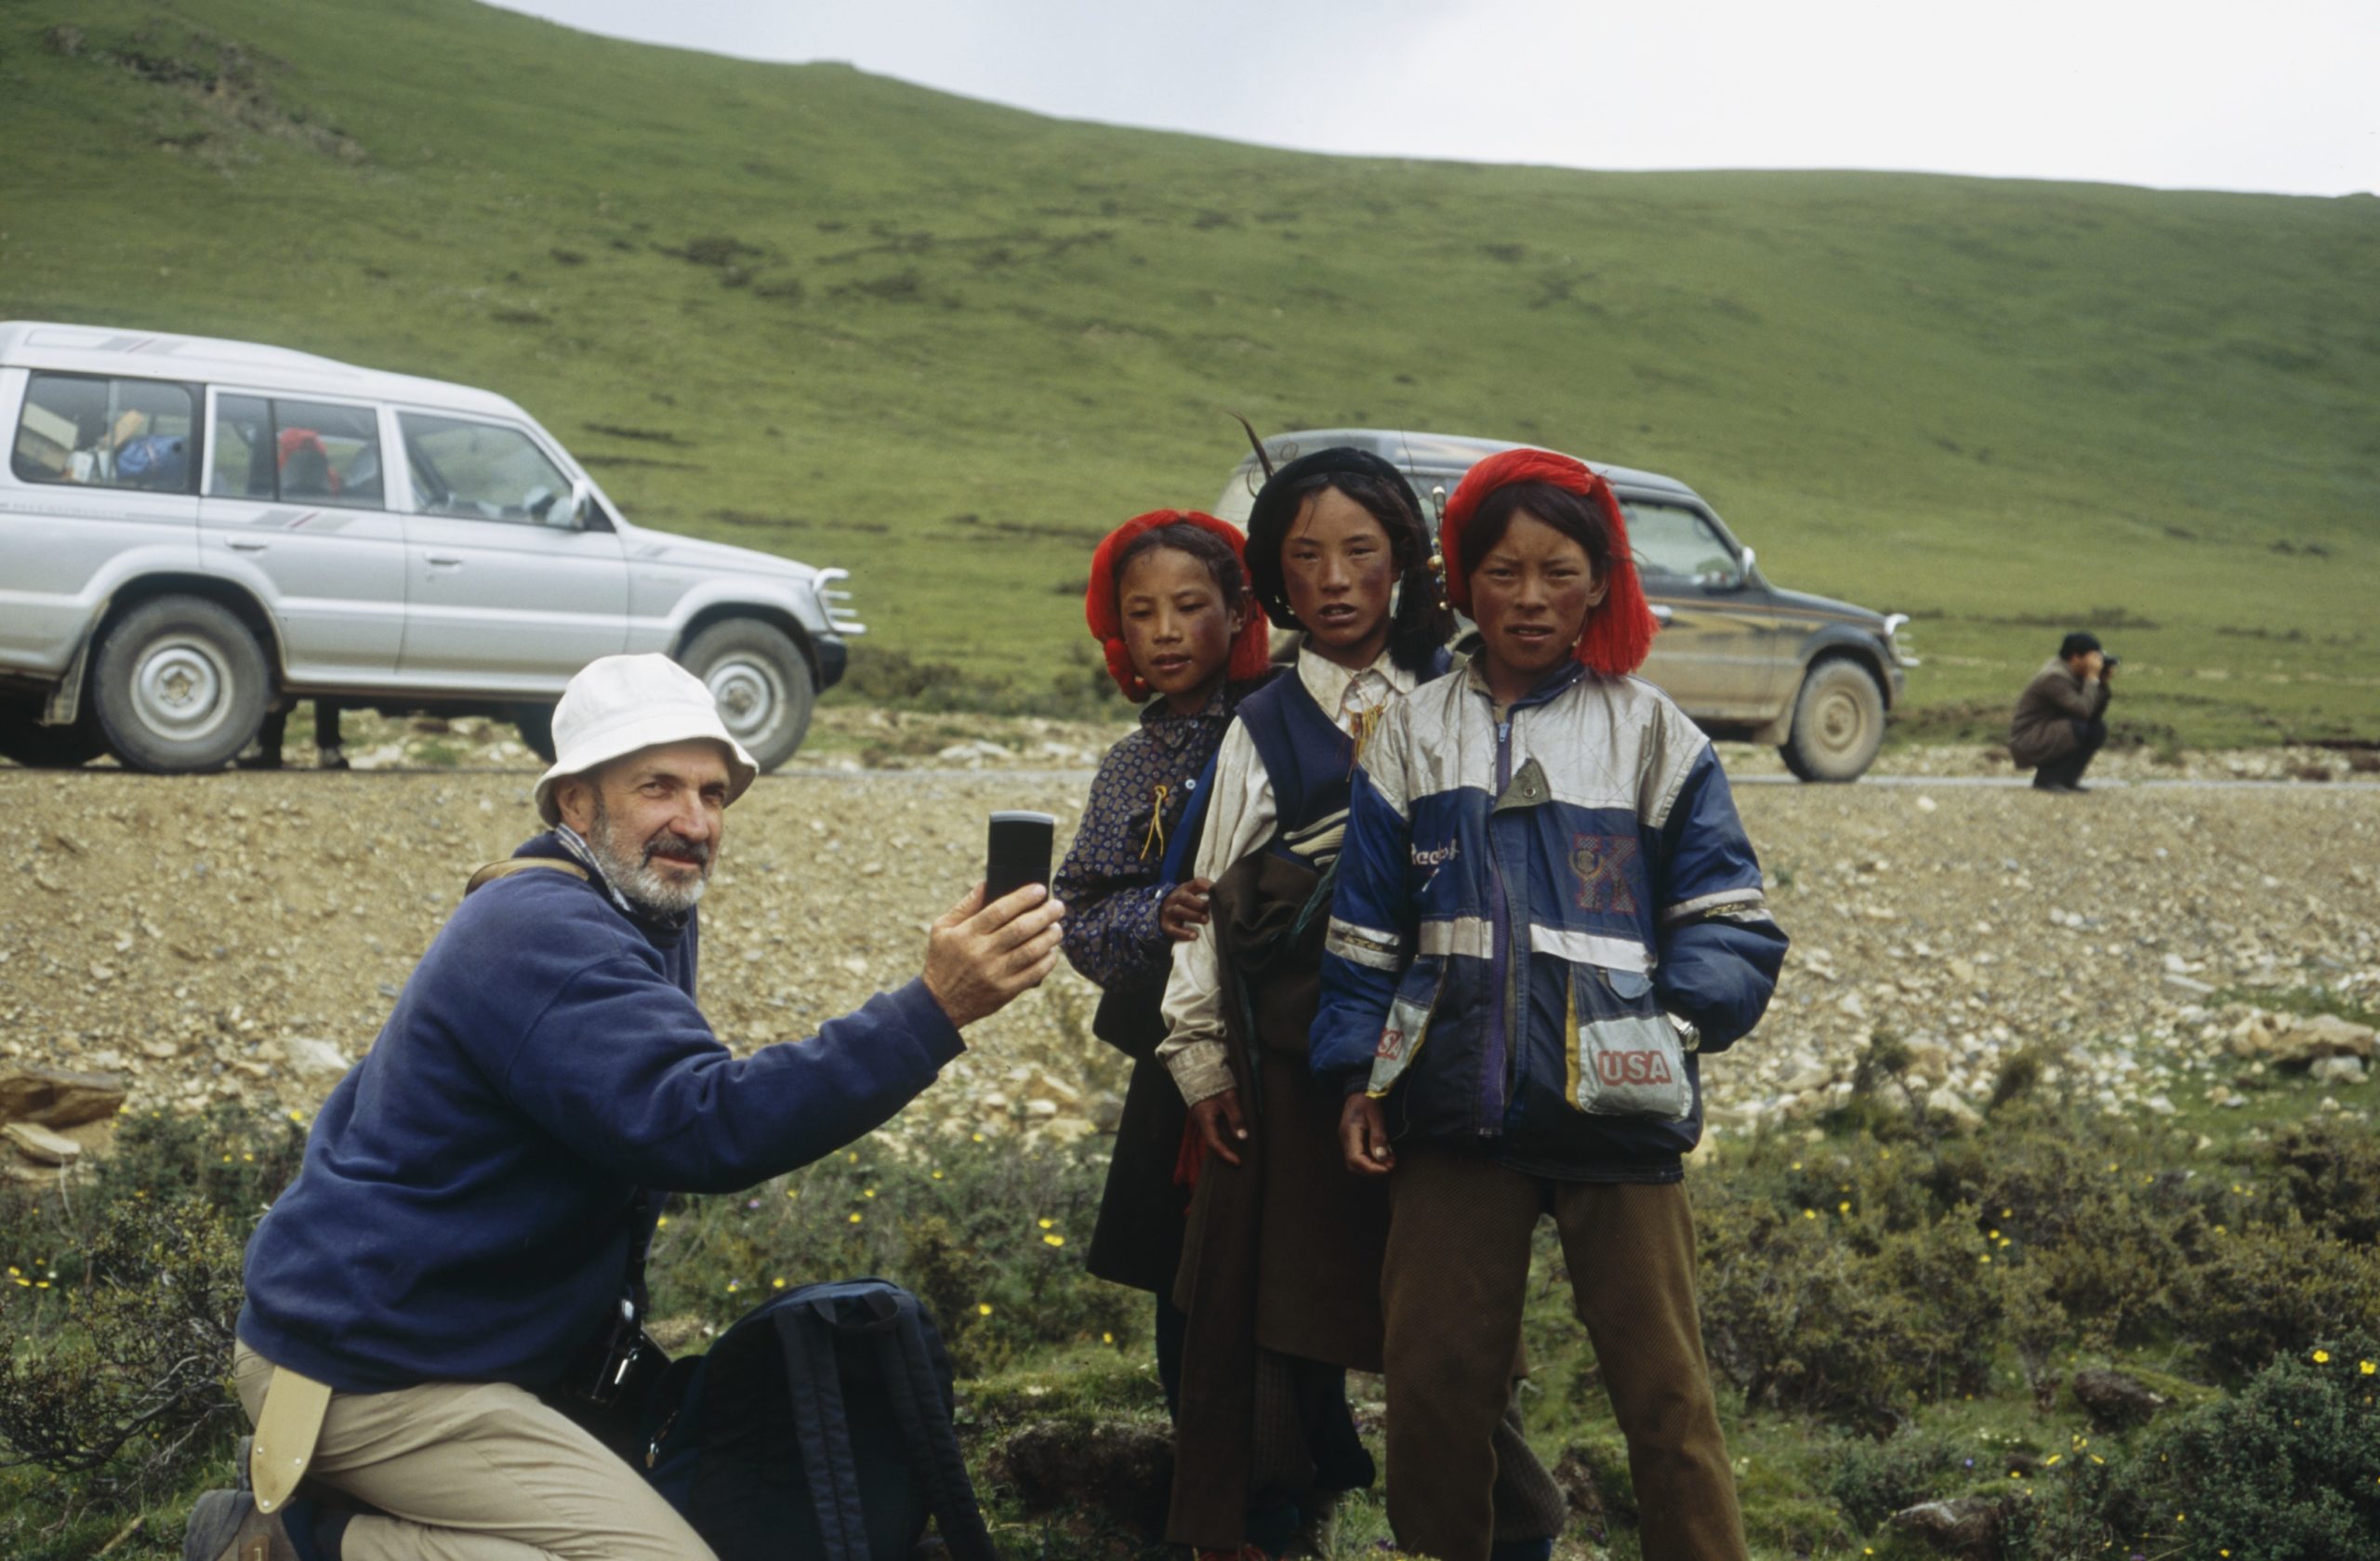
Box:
[233,1347,711,1561]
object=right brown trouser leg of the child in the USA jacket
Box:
[1554,1183,1744,1561]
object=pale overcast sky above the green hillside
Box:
[483,0,2380,195]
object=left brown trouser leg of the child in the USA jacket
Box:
[1381,1147,1540,1561]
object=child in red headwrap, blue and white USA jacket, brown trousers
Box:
[1312,450,1785,1561]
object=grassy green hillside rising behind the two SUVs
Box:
[0,0,2380,743]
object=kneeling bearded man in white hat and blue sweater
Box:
[183,655,1064,1561]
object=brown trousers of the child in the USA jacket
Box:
[1381,1147,1744,1561]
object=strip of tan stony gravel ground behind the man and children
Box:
[0,711,2380,1156]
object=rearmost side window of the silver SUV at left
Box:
[9,374,197,493]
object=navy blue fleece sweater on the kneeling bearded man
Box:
[238,835,961,1392]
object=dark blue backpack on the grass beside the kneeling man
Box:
[645,1280,995,1561]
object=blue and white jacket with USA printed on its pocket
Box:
[1312,664,1785,1180]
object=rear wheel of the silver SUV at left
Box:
[90,597,271,775]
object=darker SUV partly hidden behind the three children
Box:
[1216,429,1918,781]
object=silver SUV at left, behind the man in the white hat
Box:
[0,322,864,774]
